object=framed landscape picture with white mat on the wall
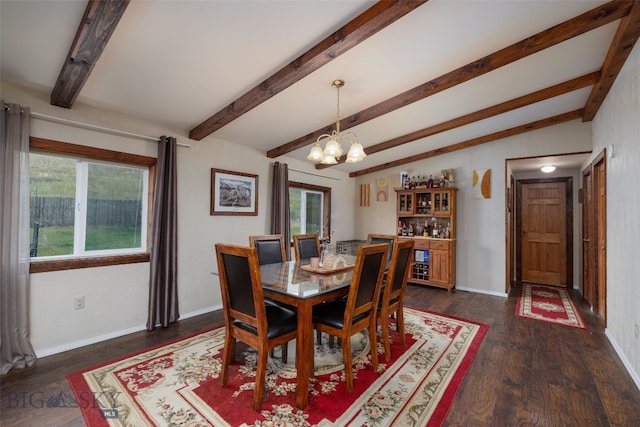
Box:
[210,168,258,216]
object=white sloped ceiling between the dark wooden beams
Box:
[0,0,619,176]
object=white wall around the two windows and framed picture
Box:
[0,82,355,356]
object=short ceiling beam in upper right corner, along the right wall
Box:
[582,0,640,122]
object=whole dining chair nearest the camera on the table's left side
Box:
[215,243,297,411]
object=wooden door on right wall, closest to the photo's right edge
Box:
[593,156,607,324]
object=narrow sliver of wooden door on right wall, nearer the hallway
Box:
[582,166,596,307]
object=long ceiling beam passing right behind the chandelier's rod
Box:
[267,1,632,158]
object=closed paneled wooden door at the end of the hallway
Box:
[519,180,570,287]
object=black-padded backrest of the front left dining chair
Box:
[216,243,266,335]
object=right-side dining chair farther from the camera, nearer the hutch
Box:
[378,239,415,362]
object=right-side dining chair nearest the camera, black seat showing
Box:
[313,244,389,392]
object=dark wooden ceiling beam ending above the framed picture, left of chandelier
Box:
[189,0,427,141]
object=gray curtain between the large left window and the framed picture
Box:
[147,136,180,330]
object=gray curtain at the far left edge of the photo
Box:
[0,100,36,374]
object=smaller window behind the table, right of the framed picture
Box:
[289,182,331,236]
